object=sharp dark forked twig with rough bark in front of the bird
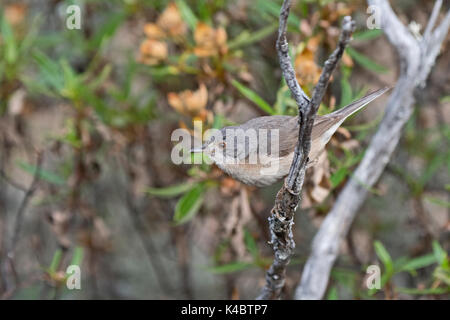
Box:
[258,0,354,299]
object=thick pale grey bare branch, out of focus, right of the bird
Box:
[295,0,450,299]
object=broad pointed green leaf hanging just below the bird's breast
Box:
[174,184,205,224]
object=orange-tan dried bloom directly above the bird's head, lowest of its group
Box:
[167,83,208,117]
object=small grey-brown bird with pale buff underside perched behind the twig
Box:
[191,88,389,187]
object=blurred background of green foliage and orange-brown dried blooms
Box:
[0,0,450,299]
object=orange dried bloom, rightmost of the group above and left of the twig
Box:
[194,22,228,57]
